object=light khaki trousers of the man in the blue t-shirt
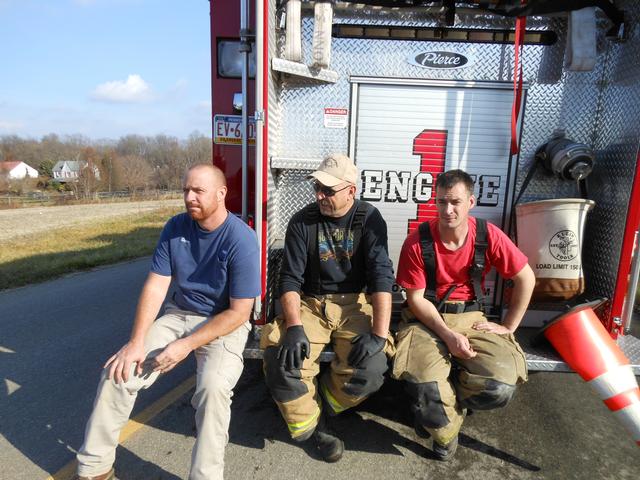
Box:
[77,304,250,480]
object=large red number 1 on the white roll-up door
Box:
[407,130,447,233]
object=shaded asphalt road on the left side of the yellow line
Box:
[0,258,191,480]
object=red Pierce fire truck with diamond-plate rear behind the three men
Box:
[210,0,640,375]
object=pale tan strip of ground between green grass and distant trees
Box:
[0,199,183,242]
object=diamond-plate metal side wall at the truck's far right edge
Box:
[584,1,640,318]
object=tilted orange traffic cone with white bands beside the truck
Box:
[543,305,640,446]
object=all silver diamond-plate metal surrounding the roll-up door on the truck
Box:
[269,0,640,334]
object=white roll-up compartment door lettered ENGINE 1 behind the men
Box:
[350,79,517,304]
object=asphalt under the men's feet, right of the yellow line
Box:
[124,361,640,480]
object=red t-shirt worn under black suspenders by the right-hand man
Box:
[396,217,527,301]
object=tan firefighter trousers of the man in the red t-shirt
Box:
[393,308,527,445]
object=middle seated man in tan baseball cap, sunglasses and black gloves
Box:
[261,154,394,462]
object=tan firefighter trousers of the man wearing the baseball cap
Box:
[260,293,394,438]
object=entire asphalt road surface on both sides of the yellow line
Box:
[0,259,640,480]
